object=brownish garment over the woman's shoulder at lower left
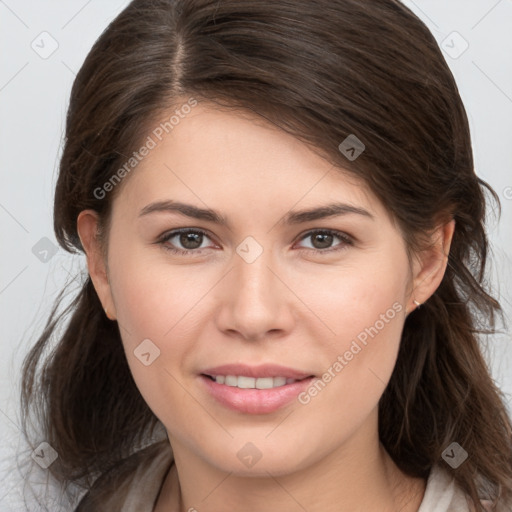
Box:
[74,439,174,512]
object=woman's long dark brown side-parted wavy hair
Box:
[22,0,512,511]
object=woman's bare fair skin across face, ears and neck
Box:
[77,98,455,512]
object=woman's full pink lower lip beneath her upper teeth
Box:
[199,375,314,414]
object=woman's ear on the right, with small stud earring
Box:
[407,219,455,311]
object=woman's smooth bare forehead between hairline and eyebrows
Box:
[116,103,386,224]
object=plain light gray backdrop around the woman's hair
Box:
[0,0,512,512]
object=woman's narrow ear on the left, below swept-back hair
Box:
[76,210,116,320]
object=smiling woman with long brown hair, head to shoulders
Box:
[19,0,512,512]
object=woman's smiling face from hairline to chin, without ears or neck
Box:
[80,103,444,475]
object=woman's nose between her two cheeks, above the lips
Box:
[217,249,299,341]
